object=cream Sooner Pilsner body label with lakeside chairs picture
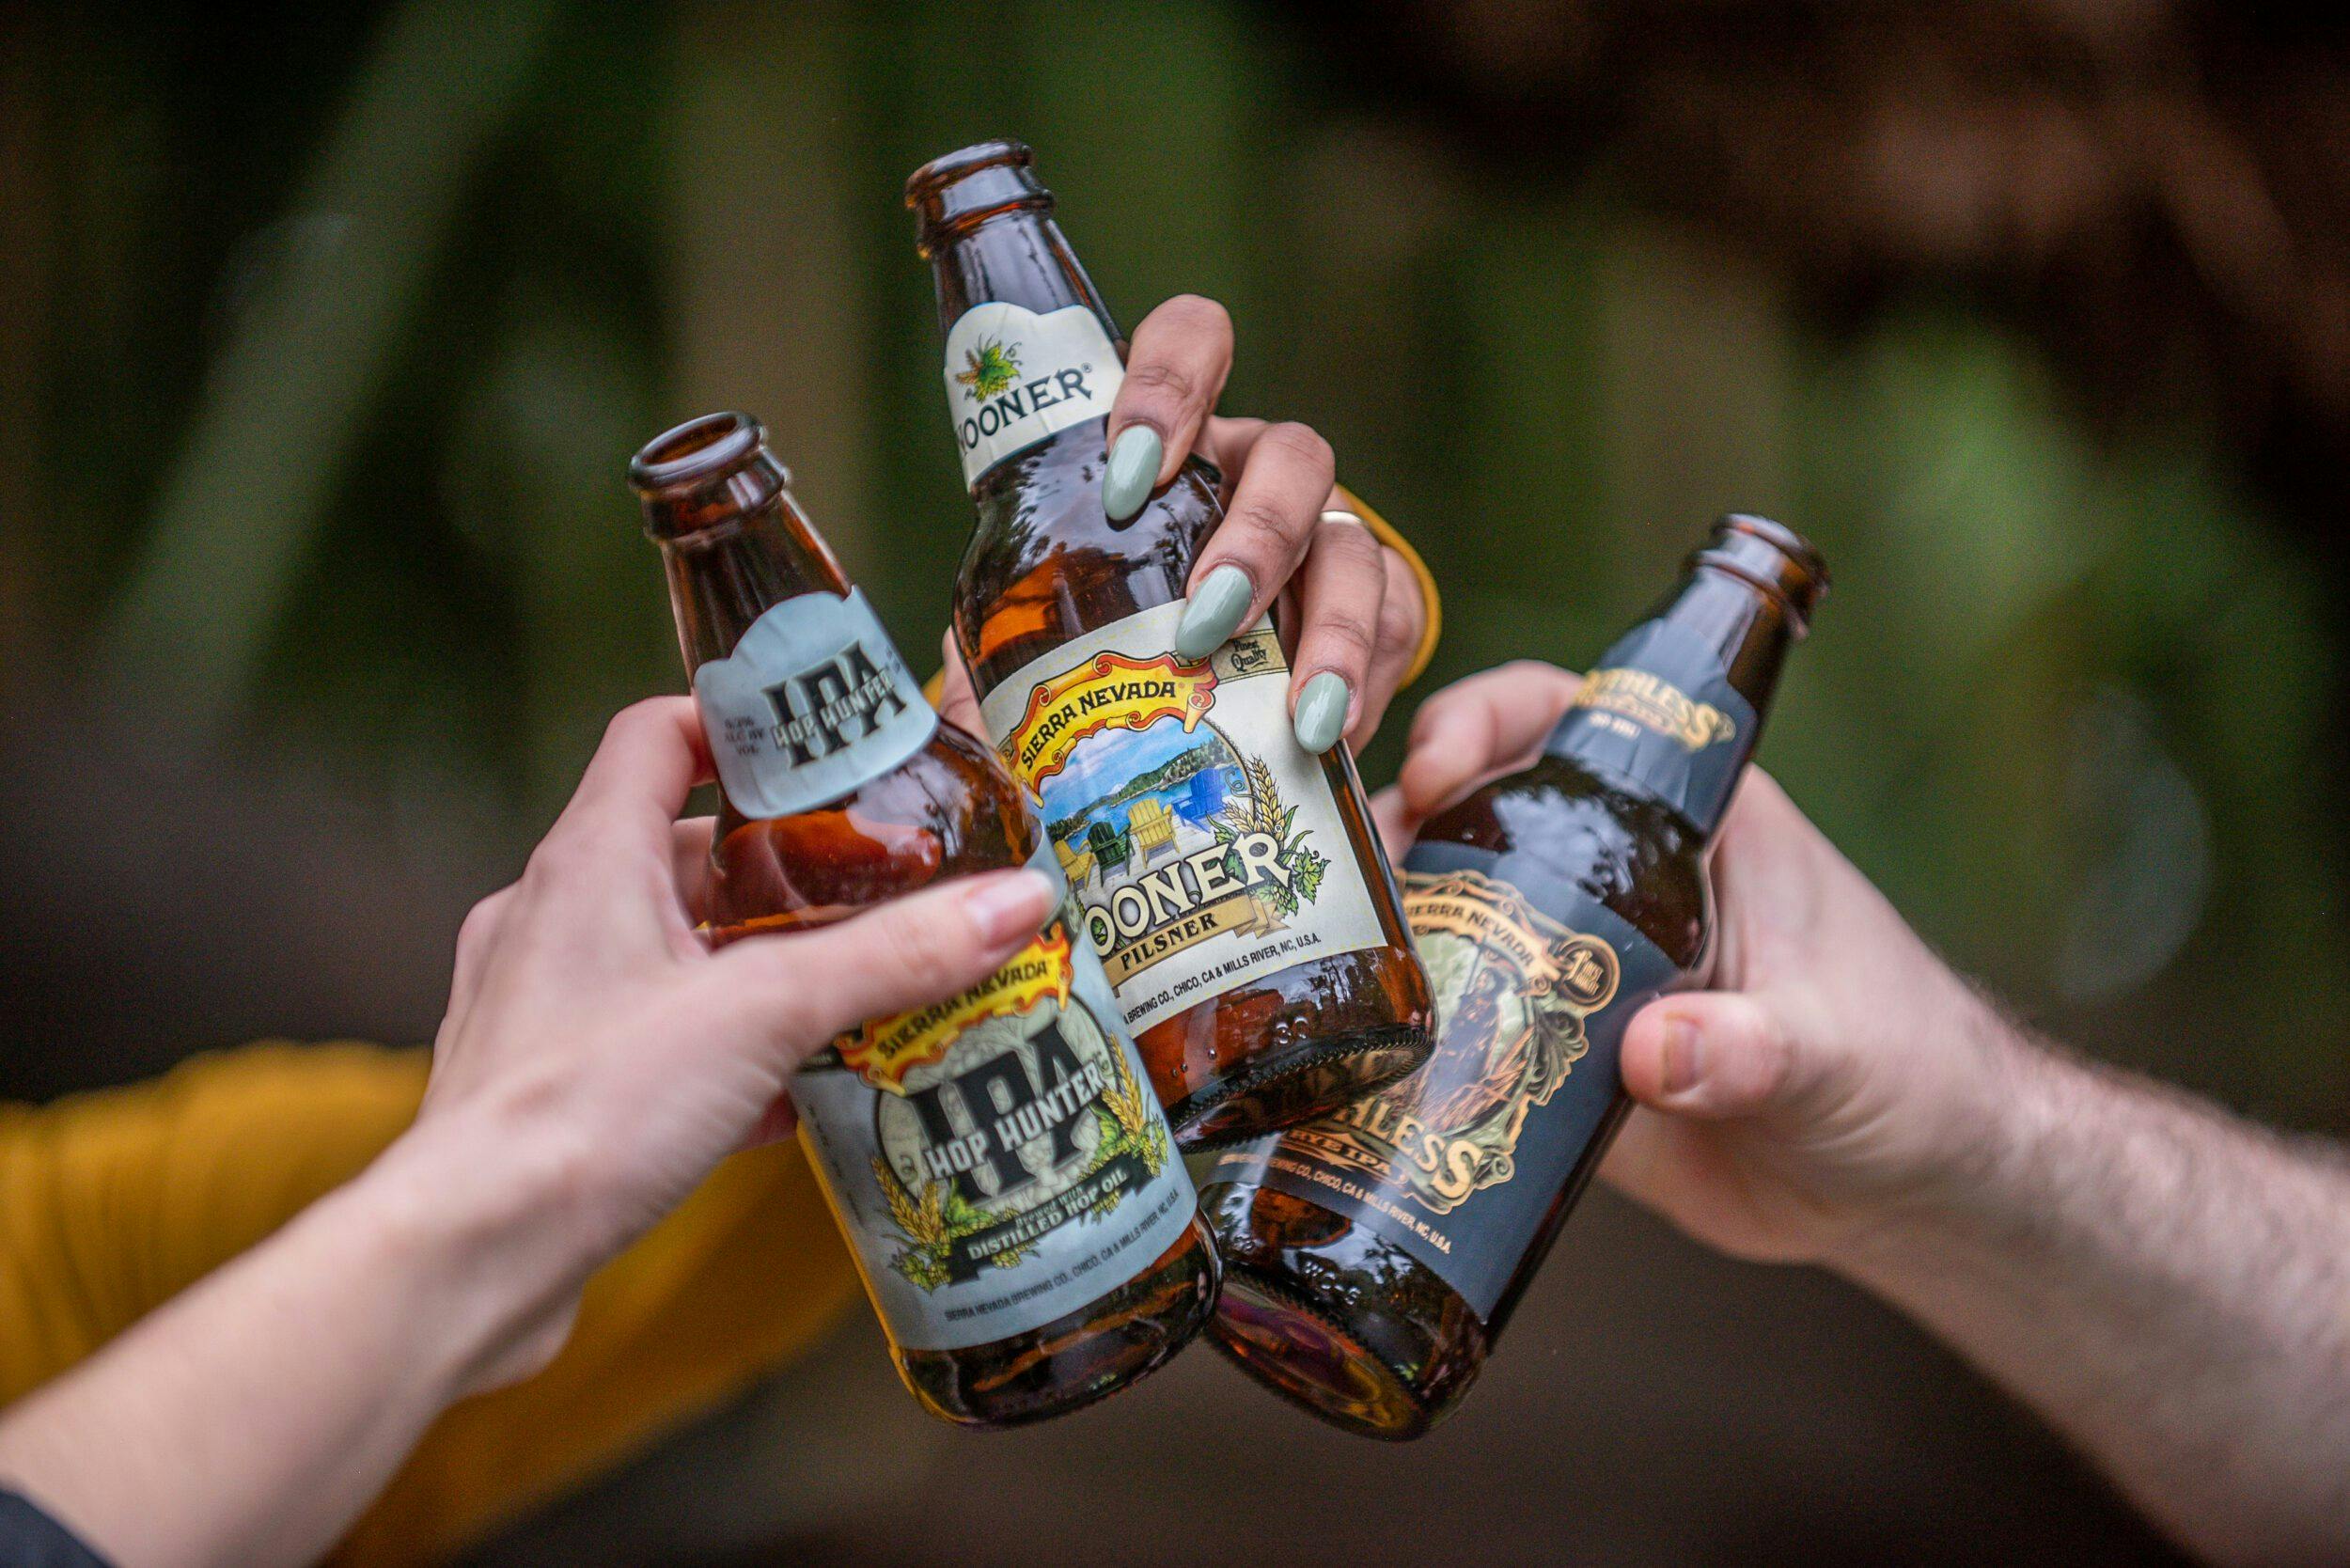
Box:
[980,602,1386,1032]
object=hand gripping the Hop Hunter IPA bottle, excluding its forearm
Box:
[404,698,1053,1354]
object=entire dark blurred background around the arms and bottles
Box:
[0,0,2350,1563]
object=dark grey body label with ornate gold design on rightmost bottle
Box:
[1208,860,1678,1321]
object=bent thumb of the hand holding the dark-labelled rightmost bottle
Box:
[1624,992,1817,1121]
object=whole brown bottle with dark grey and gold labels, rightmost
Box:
[1201,517,1828,1438]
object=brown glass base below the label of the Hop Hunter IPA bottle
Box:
[891,1217,1222,1432]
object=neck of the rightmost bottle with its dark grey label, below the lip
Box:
[1546,559,1803,841]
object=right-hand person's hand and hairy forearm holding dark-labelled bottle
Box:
[1372,663,2350,1563]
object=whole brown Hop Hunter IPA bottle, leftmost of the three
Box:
[630,414,1217,1427]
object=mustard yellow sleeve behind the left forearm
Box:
[0,1043,858,1565]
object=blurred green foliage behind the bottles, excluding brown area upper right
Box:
[0,0,2350,1126]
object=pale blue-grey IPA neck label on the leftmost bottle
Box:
[694,588,938,818]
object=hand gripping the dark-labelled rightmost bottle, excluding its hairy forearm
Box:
[1372,661,2019,1260]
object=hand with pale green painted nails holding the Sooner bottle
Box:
[1086,294,1429,752]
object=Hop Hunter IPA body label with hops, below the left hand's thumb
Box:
[792,855,1197,1349]
